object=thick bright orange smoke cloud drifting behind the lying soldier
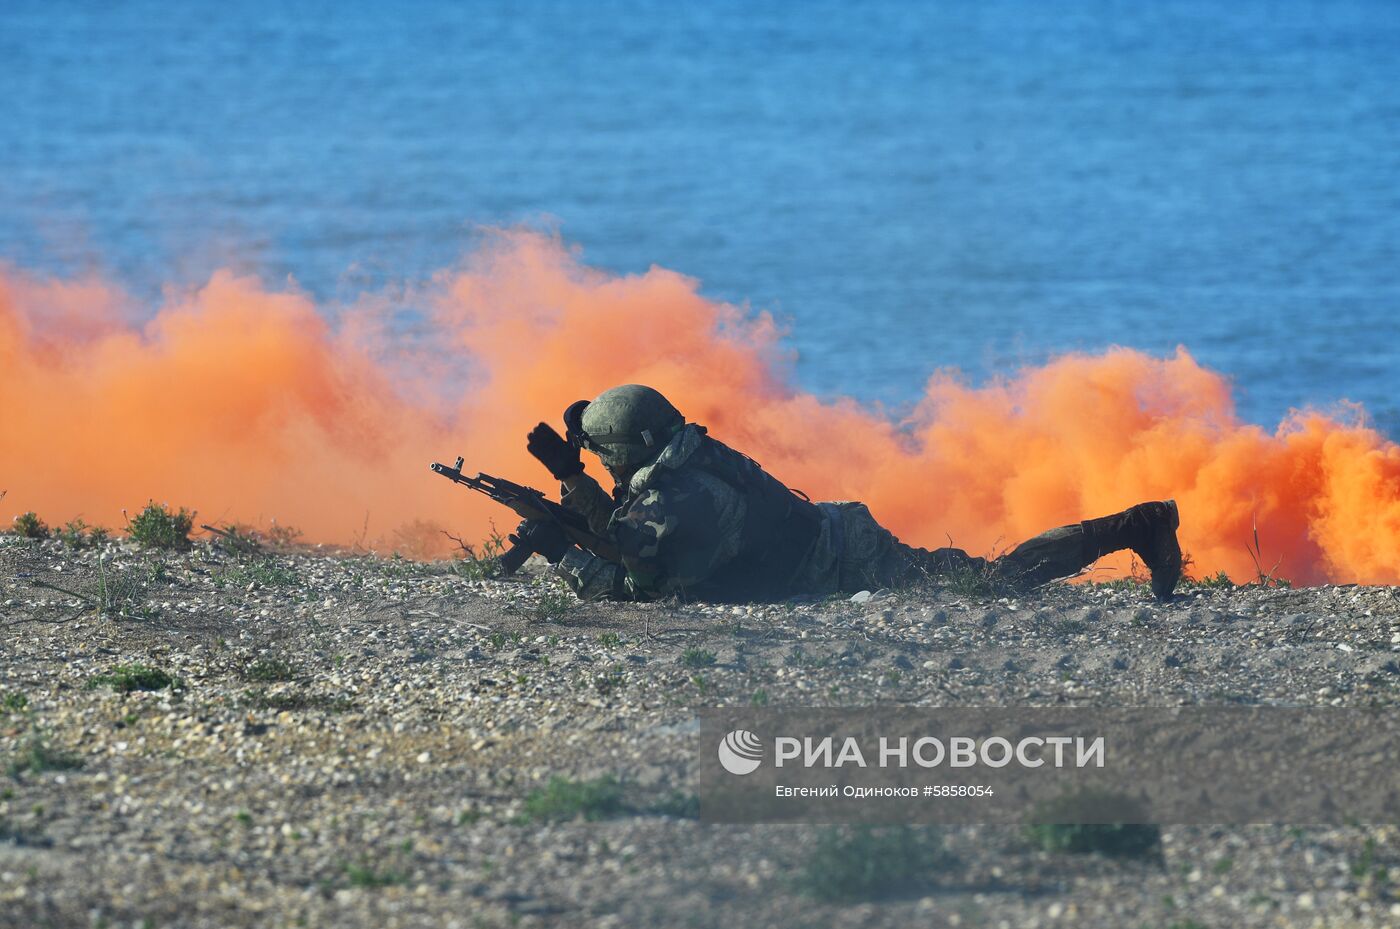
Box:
[0,232,1400,582]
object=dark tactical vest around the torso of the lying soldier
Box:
[685,427,822,600]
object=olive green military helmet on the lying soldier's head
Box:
[570,383,686,471]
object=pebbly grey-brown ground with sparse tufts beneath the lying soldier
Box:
[0,537,1400,929]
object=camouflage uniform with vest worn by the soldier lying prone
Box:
[556,424,1092,600]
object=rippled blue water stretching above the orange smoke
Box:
[0,0,1400,435]
